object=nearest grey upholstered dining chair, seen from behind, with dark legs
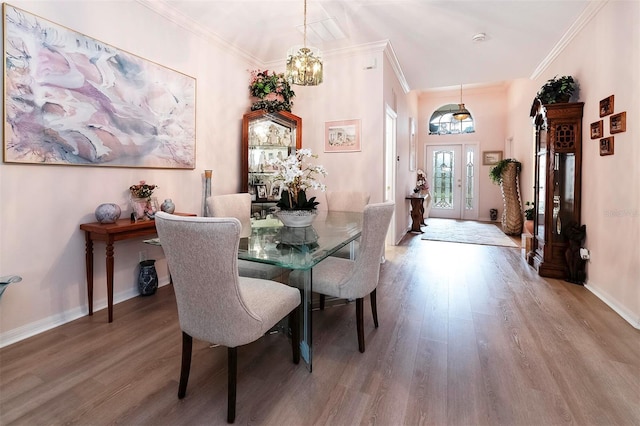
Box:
[155,212,300,423]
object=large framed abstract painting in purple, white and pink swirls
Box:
[2,3,196,169]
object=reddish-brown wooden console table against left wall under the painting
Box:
[80,213,195,322]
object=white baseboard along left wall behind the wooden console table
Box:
[0,281,169,348]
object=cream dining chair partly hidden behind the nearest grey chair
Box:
[207,193,285,280]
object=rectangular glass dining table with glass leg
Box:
[238,211,363,371]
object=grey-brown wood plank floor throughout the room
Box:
[0,235,640,425]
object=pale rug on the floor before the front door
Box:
[422,218,518,247]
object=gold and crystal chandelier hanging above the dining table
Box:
[285,0,322,86]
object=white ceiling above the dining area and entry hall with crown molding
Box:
[138,0,607,90]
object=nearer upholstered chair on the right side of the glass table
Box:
[289,201,395,352]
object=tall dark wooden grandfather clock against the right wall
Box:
[528,102,584,278]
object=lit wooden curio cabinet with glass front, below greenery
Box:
[242,110,302,208]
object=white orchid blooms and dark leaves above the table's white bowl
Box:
[268,149,327,210]
